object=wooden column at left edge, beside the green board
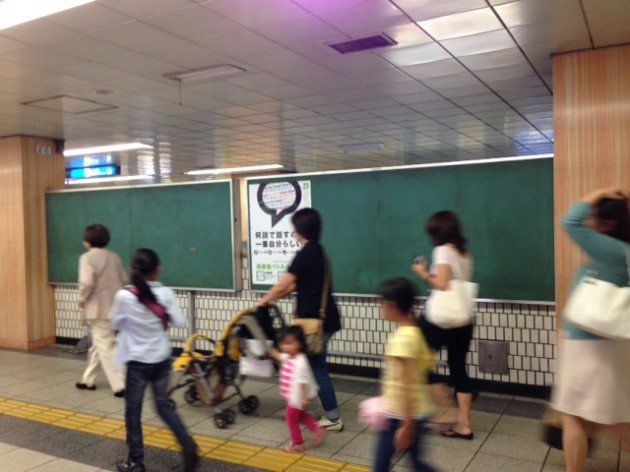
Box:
[0,136,65,349]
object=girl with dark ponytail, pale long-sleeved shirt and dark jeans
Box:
[111,249,199,472]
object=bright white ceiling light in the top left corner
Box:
[0,0,95,30]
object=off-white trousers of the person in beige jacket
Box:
[81,320,125,393]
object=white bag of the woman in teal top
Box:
[564,261,630,341]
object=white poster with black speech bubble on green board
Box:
[248,180,311,286]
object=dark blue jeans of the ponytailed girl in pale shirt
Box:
[125,360,197,462]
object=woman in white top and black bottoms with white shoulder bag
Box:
[412,211,473,440]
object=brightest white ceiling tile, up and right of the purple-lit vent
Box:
[418,8,503,40]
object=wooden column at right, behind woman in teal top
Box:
[553,46,630,313]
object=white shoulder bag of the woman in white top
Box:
[426,279,479,329]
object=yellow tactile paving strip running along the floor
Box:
[0,397,371,472]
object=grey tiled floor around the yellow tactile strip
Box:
[0,347,630,472]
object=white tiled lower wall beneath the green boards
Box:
[55,258,556,386]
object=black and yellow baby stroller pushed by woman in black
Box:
[168,305,285,429]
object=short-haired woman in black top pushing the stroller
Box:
[258,208,343,431]
